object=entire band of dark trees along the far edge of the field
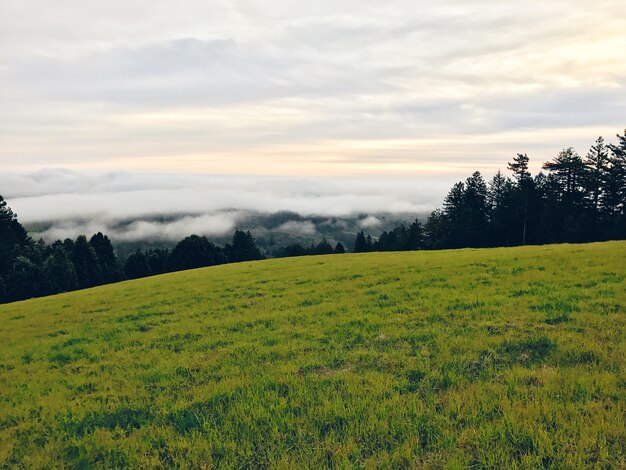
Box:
[0,131,626,302]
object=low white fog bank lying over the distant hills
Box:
[0,169,453,241]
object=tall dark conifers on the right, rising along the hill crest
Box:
[354,131,626,252]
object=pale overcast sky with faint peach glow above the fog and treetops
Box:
[0,0,626,235]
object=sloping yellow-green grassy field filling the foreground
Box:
[0,242,626,468]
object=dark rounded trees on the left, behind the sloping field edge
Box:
[0,206,264,303]
